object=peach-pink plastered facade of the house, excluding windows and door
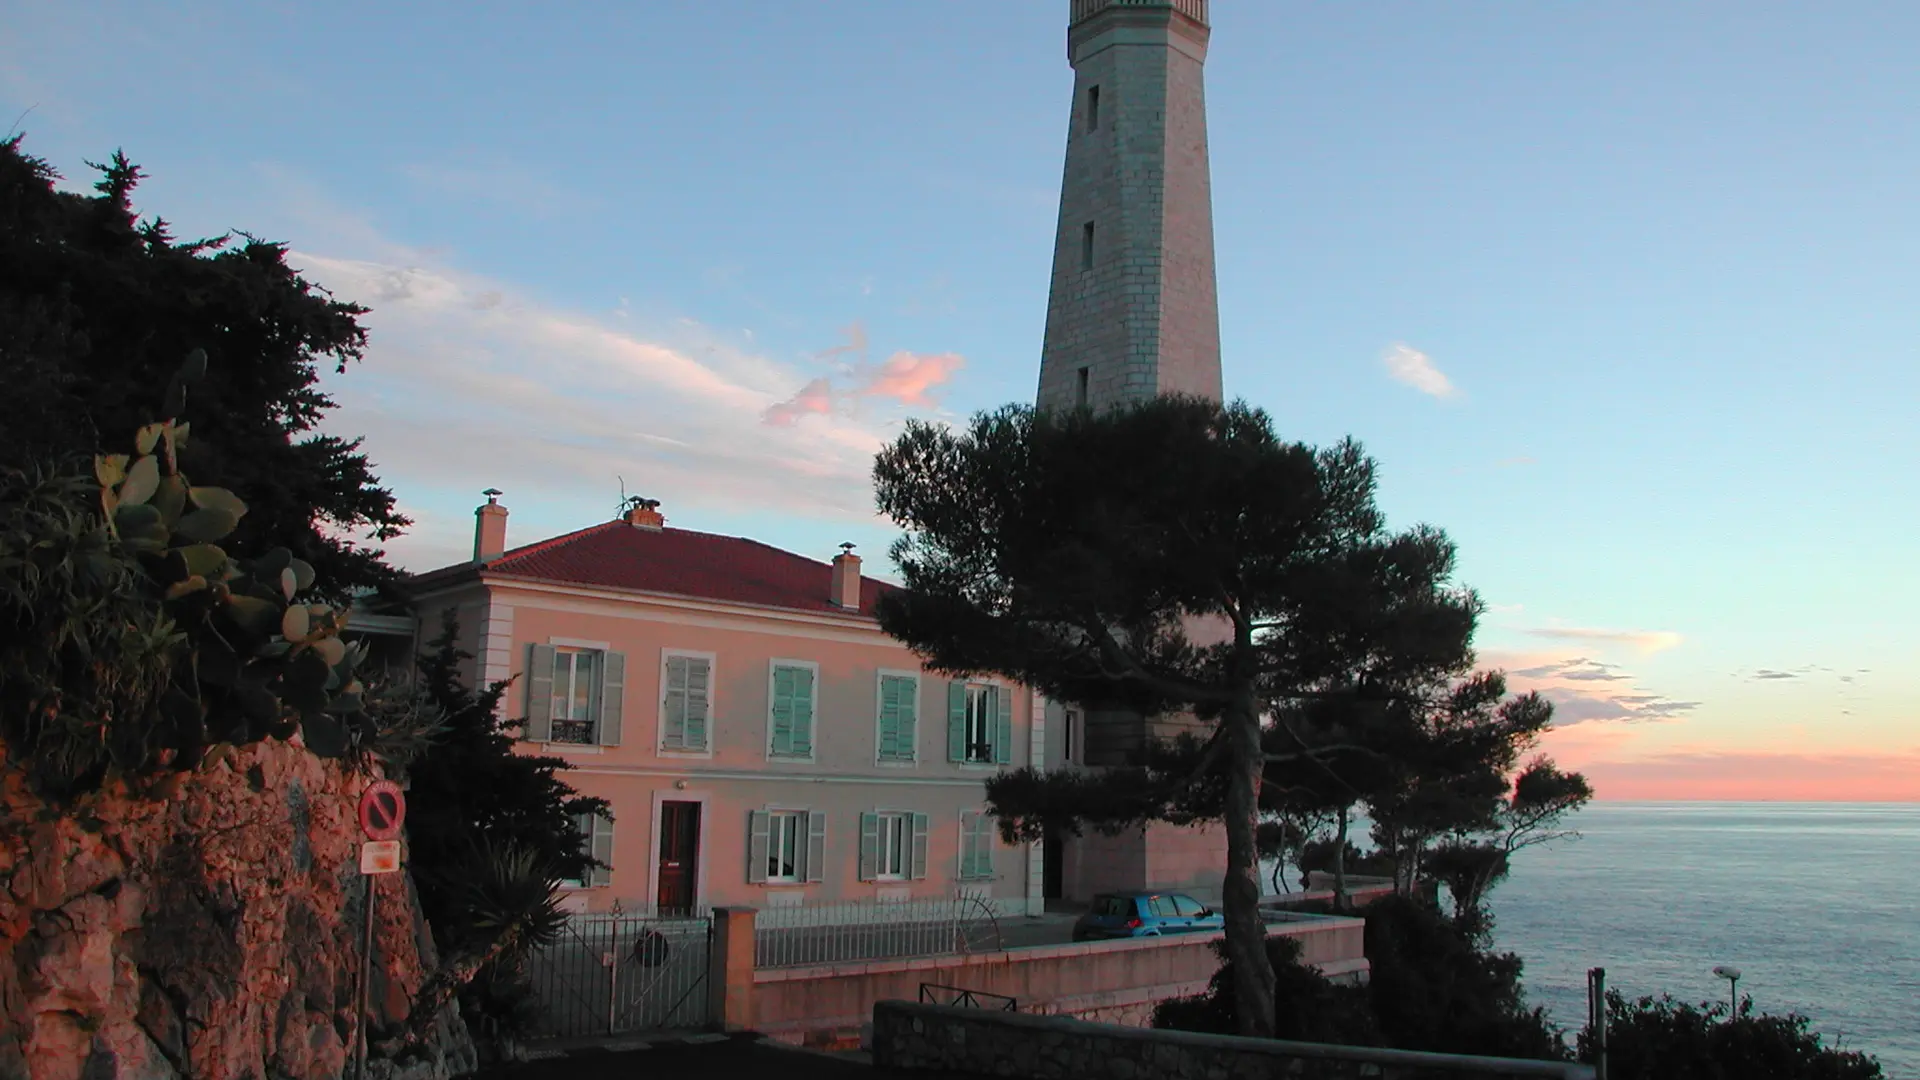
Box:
[422,582,1039,913]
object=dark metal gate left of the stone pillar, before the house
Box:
[528,915,712,1038]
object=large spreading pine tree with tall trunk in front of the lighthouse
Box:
[874,398,1480,1034]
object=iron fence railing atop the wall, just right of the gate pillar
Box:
[753,897,1004,969]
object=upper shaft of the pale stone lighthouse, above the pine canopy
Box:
[1039,0,1221,409]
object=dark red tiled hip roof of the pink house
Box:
[428,521,893,615]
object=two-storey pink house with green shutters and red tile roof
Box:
[397,492,1044,913]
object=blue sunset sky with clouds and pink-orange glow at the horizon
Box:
[0,0,1920,799]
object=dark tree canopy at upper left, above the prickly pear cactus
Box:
[0,136,409,600]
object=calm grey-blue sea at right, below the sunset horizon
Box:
[1490,801,1920,1080]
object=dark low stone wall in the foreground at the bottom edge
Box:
[874,1001,1594,1080]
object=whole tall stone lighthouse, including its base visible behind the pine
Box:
[1037,0,1227,899]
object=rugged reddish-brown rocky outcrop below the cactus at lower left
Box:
[0,742,474,1080]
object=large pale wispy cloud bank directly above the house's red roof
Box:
[290,250,958,569]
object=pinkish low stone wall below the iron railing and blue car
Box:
[743,915,1367,1042]
